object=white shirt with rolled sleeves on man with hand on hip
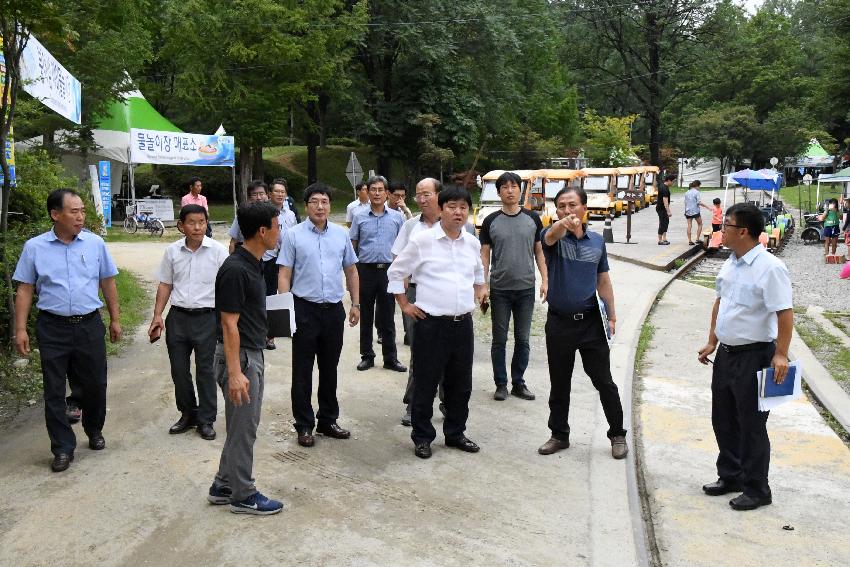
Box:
[387,223,484,315]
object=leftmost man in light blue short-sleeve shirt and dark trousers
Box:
[13,189,121,472]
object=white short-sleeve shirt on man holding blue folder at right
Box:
[714,244,793,346]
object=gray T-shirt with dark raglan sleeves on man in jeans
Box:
[480,209,543,291]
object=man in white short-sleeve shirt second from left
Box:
[148,205,227,440]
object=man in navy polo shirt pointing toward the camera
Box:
[537,187,628,459]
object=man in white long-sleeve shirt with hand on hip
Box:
[387,184,484,459]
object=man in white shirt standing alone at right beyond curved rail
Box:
[698,203,794,510]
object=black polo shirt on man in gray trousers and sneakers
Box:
[215,247,268,349]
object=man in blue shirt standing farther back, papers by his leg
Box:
[348,176,407,372]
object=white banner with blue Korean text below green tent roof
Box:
[130,128,236,167]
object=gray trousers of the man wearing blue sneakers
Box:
[213,344,265,502]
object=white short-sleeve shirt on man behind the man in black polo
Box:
[156,236,228,309]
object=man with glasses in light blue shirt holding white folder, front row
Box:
[277,183,360,447]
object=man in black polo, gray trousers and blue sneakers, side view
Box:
[207,201,283,515]
